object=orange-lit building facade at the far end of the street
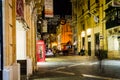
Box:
[57,19,73,50]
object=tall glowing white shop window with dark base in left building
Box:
[16,20,27,75]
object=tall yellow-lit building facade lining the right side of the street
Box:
[72,0,120,58]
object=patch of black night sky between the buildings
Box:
[53,0,72,16]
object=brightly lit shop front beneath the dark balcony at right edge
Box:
[107,26,120,58]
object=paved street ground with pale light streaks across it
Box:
[29,56,120,80]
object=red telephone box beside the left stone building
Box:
[36,40,46,62]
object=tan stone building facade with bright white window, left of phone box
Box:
[0,0,43,80]
